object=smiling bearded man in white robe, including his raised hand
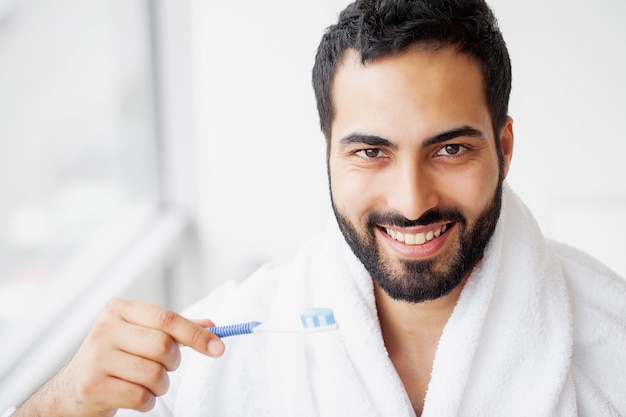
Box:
[9,0,626,417]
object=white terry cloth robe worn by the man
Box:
[120,186,626,417]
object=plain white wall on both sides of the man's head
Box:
[193,0,626,290]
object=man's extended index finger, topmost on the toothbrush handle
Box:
[107,300,224,357]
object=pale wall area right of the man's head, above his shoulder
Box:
[491,0,626,277]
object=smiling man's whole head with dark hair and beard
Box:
[313,0,513,302]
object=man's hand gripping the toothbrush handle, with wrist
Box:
[14,300,224,417]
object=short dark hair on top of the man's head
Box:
[313,0,511,145]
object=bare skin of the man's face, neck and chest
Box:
[328,47,513,415]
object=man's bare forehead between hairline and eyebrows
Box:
[331,47,491,140]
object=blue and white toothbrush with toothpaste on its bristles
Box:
[207,307,339,337]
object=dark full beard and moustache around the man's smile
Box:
[331,178,502,303]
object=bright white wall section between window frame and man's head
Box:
[194,0,339,281]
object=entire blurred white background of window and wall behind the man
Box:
[0,0,626,411]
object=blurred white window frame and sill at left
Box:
[0,0,200,410]
